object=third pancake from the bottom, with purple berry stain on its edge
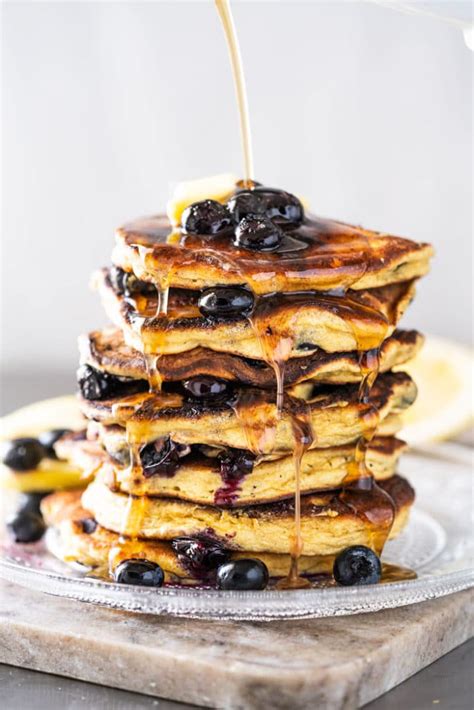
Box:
[56,437,406,507]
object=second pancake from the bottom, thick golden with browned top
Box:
[82,474,414,555]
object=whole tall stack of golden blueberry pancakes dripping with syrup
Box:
[43,199,431,584]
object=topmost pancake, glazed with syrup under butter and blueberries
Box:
[113,215,433,298]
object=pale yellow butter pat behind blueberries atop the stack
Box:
[166,173,238,227]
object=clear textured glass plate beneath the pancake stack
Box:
[0,454,474,621]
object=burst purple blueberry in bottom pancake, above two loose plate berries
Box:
[171,536,230,581]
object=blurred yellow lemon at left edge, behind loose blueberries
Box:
[0,395,85,493]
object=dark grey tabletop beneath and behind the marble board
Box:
[0,372,474,710]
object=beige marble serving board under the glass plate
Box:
[0,582,474,710]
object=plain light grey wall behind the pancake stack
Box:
[2,0,472,370]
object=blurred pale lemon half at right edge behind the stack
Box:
[398,335,474,446]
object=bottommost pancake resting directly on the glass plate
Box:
[41,491,366,584]
